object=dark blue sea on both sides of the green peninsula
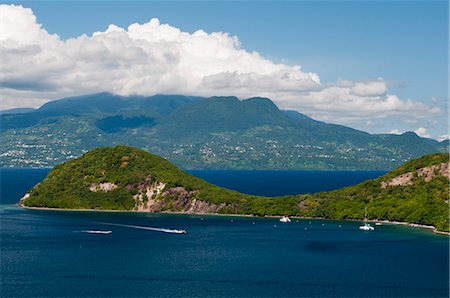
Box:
[0,169,449,297]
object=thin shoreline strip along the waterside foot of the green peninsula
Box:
[15,203,450,236]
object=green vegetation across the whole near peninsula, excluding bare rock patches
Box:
[25,146,449,231]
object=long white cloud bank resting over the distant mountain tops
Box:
[0,5,442,137]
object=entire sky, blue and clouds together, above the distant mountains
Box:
[0,1,449,139]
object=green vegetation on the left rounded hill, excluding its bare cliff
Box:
[25,146,264,211]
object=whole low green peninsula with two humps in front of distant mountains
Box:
[19,145,449,232]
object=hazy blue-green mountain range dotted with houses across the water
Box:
[0,93,448,170]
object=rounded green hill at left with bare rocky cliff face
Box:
[24,146,270,212]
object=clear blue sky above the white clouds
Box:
[1,1,449,137]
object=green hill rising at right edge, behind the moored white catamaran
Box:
[303,153,449,232]
